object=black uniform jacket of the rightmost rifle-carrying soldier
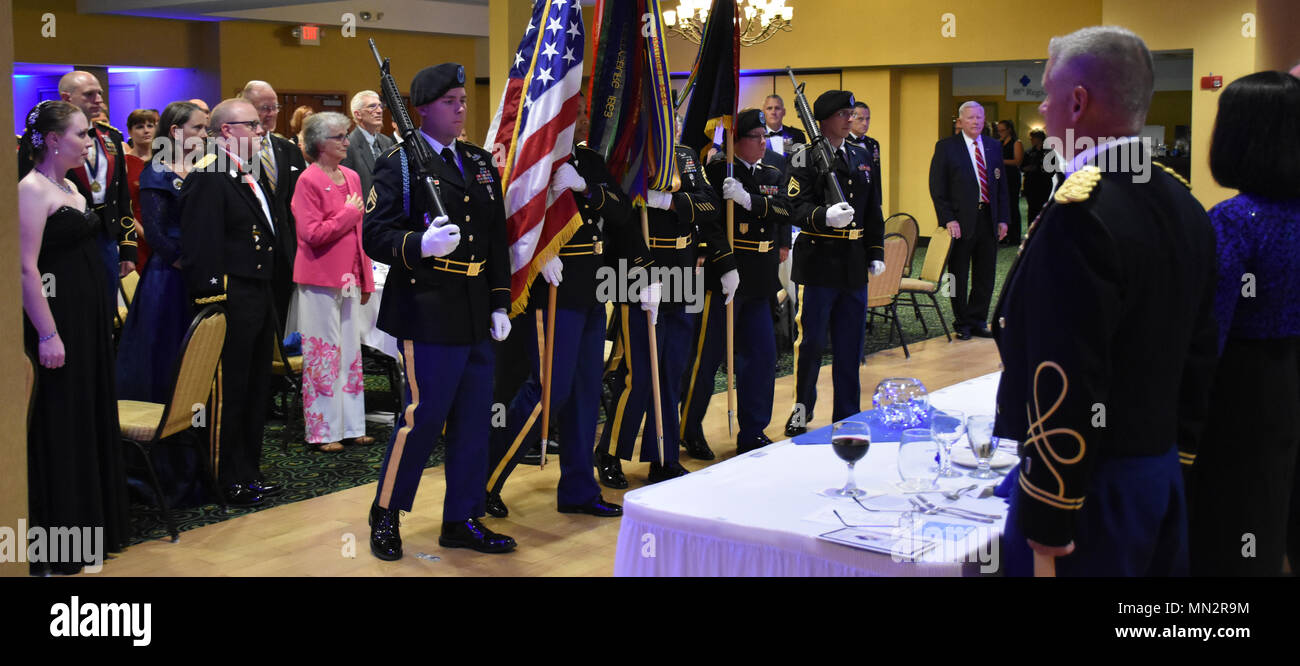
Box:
[783,142,885,289]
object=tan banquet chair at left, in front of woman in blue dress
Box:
[117,306,226,542]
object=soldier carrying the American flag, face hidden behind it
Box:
[488,92,634,518]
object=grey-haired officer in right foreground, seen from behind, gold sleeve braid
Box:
[993,26,1218,576]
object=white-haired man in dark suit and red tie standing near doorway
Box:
[930,101,1011,340]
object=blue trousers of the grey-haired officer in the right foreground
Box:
[1002,446,1190,578]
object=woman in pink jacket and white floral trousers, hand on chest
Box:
[291,113,374,451]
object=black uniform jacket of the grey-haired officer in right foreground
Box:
[993,153,1218,545]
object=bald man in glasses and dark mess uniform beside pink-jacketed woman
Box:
[181,99,282,505]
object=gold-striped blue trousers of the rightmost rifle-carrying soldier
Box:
[794,285,867,424]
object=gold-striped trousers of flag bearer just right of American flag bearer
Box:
[599,306,694,464]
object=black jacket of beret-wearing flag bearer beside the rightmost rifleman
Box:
[705,157,790,300]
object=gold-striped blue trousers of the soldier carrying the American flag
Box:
[488,304,605,505]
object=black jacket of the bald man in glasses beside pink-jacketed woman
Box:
[181,143,278,304]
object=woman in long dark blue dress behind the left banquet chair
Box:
[117,101,208,506]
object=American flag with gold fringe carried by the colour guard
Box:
[488,0,584,316]
